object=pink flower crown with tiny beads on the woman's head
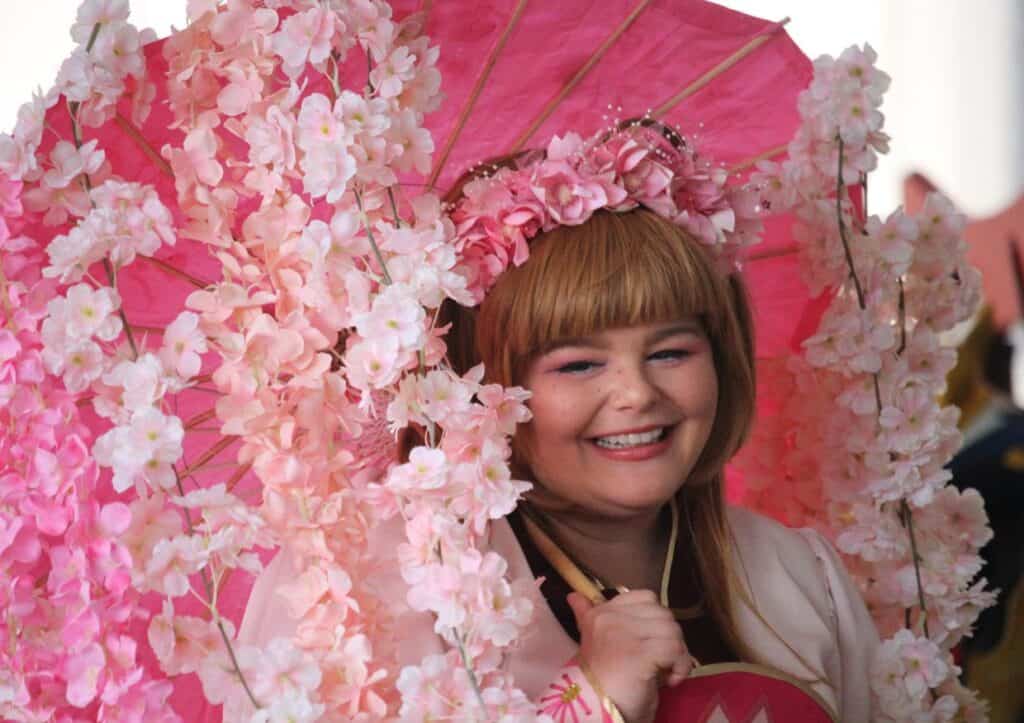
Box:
[450,120,762,303]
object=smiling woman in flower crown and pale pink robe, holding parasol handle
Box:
[234,136,878,723]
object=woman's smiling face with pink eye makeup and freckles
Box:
[523,317,718,517]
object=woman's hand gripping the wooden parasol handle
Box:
[568,590,693,723]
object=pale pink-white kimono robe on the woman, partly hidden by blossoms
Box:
[224,507,879,723]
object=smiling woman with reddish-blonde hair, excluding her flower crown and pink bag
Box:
[413,203,878,721]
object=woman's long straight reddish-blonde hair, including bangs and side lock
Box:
[441,203,755,660]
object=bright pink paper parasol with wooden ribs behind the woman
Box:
[4,0,820,721]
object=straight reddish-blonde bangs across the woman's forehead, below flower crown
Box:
[477,209,730,384]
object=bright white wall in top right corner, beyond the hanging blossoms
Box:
[881,0,1024,216]
